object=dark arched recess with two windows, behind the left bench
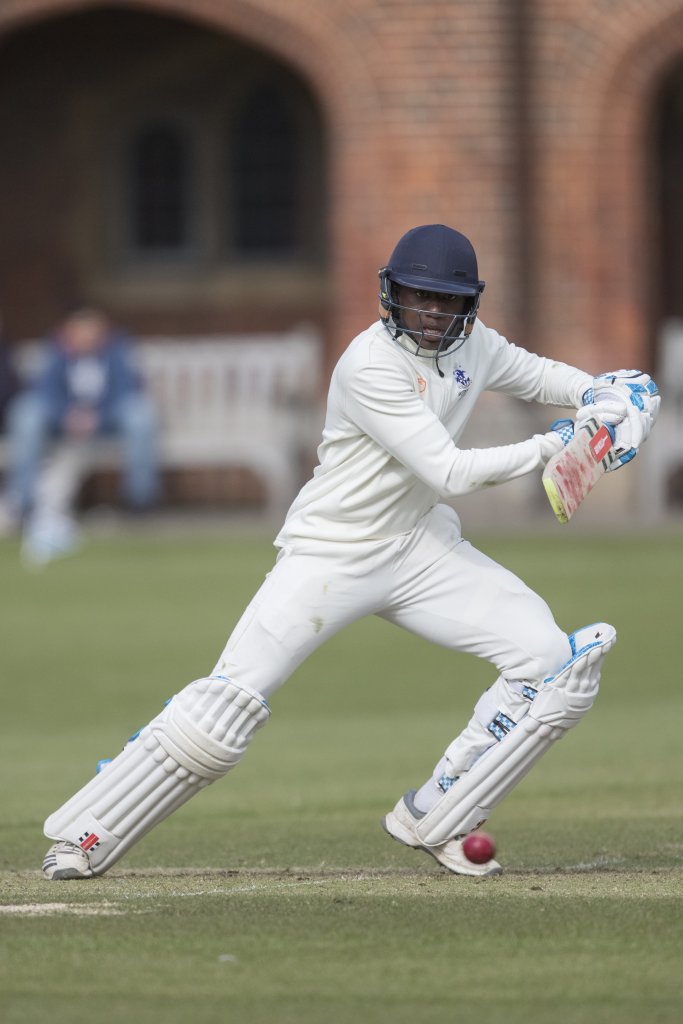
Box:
[0,7,329,338]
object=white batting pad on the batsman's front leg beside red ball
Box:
[416,623,616,846]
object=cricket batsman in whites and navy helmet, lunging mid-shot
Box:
[43,224,659,880]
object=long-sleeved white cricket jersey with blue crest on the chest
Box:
[275,319,593,547]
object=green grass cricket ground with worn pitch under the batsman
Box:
[0,526,683,1024]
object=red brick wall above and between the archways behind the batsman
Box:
[0,0,683,369]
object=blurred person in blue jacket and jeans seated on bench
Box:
[0,306,159,560]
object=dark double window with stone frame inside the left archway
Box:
[116,79,325,267]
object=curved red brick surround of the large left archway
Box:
[0,0,385,360]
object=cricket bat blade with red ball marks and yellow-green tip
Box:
[543,417,616,522]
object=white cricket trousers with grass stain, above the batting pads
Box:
[214,505,571,697]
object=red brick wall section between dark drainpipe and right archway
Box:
[535,0,683,369]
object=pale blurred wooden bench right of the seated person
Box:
[0,326,324,515]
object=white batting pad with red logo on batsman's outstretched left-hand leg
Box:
[45,676,270,874]
